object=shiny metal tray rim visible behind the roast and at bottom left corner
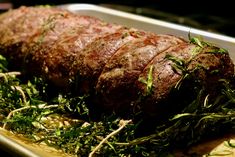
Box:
[0,4,235,157]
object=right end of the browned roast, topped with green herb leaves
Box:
[136,43,234,116]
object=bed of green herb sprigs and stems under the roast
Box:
[0,43,235,157]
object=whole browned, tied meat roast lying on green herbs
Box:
[0,7,234,114]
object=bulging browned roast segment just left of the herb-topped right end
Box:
[96,35,184,108]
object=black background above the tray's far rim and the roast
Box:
[0,0,235,37]
